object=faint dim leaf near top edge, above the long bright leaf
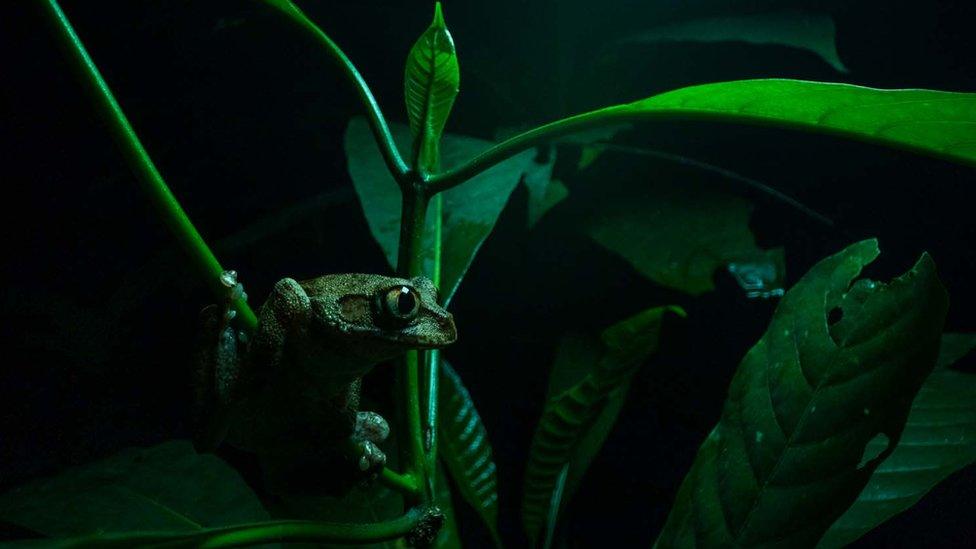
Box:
[619,10,848,72]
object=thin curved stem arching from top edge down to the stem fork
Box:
[264,0,409,186]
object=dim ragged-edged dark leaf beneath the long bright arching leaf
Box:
[582,178,782,295]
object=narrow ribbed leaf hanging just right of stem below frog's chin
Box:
[438,361,501,547]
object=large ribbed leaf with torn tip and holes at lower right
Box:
[657,240,948,547]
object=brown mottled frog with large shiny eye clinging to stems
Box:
[194,271,457,494]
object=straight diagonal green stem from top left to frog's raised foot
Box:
[44,0,257,330]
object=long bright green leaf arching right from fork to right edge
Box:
[442,79,976,184]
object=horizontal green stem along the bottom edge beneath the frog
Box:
[54,508,425,549]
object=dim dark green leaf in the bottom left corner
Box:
[0,440,269,537]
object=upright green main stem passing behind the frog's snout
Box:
[397,184,433,502]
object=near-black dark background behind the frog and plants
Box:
[0,0,976,548]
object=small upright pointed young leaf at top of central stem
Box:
[403,2,461,171]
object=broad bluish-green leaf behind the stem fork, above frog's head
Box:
[345,118,552,303]
